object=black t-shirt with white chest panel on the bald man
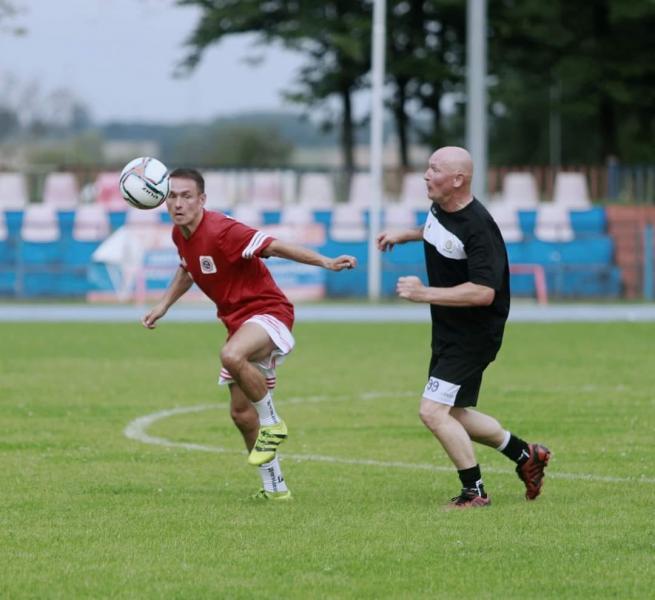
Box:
[423,198,510,362]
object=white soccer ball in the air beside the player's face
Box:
[119,156,169,209]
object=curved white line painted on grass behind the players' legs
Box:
[123,392,655,484]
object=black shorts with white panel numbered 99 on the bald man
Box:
[423,354,491,407]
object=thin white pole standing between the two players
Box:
[368,0,387,300]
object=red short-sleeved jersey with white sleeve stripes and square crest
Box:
[173,211,294,335]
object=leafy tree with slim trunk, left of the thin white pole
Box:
[178,0,371,173]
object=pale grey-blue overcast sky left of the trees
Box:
[0,0,302,122]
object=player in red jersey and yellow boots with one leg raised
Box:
[142,169,357,500]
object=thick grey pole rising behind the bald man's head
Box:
[466,0,487,202]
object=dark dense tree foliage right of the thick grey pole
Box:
[490,0,655,162]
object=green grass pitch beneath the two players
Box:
[0,322,655,599]
